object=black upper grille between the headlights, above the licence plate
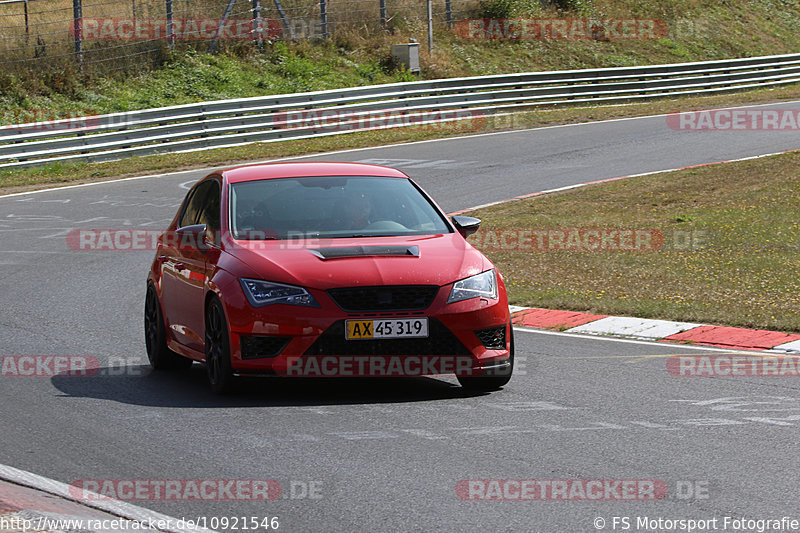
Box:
[328,285,439,313]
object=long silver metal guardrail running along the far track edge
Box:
[0,54,800,170]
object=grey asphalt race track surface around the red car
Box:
[0,102,800,532]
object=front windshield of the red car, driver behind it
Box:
[229,176,451,240]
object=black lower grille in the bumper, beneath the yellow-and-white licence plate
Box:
[304,318,471,355]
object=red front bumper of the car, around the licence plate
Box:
[223,285,511,376]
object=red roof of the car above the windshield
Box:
[222,161,408,183]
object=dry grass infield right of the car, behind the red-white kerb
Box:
[470,153,800,332]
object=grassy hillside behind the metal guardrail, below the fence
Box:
[0,0,800,120]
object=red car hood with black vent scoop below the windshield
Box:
[226,233,491,290]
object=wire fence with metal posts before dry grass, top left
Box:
[0,0,477,71]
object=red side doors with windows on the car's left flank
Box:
[162,178,220,353]
